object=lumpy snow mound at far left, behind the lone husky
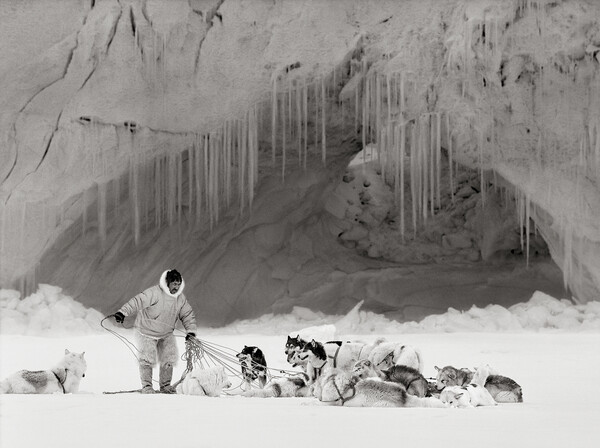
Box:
[0,284,104,336]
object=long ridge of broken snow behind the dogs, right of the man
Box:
[213,291,600,340]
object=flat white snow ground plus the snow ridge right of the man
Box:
[0,288,600,448]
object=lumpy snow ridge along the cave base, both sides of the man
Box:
[0,284,600,341]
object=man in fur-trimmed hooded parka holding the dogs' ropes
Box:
[114,269,196,394]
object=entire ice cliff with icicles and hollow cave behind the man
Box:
[0,0,600,324]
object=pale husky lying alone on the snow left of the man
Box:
[0,349,87,394]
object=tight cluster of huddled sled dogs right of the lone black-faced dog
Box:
[244,336,523,408]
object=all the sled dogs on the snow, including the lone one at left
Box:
[0,336,523,408]
